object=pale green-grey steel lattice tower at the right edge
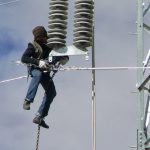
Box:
[137,0,150,150]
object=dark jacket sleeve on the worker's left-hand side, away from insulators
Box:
[21,43,39,65]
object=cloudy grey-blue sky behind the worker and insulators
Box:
[0,0,149,150]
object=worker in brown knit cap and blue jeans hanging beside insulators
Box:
[21,26,69,128]
